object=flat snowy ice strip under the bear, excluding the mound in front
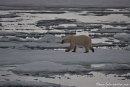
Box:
[0,48,130,65]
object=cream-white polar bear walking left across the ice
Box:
[61,35,94,53]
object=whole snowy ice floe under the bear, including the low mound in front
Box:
[0,48,130,75]
